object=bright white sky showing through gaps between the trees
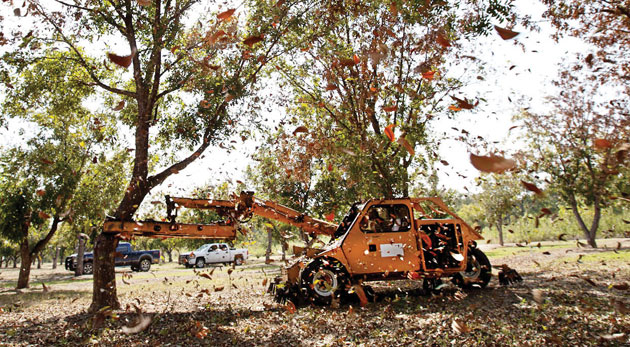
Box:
[0,1,585,200]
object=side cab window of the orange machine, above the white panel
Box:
[359,204,411,233]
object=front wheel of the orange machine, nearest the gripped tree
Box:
[302,259,349,305]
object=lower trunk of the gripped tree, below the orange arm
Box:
[88,233,120,312]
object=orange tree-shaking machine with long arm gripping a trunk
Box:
[104,192,498,303]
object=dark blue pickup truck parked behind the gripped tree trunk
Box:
[66,242,160,274]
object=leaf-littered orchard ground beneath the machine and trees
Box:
[0,239,630,346]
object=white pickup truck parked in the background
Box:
[179,243,249,268]
